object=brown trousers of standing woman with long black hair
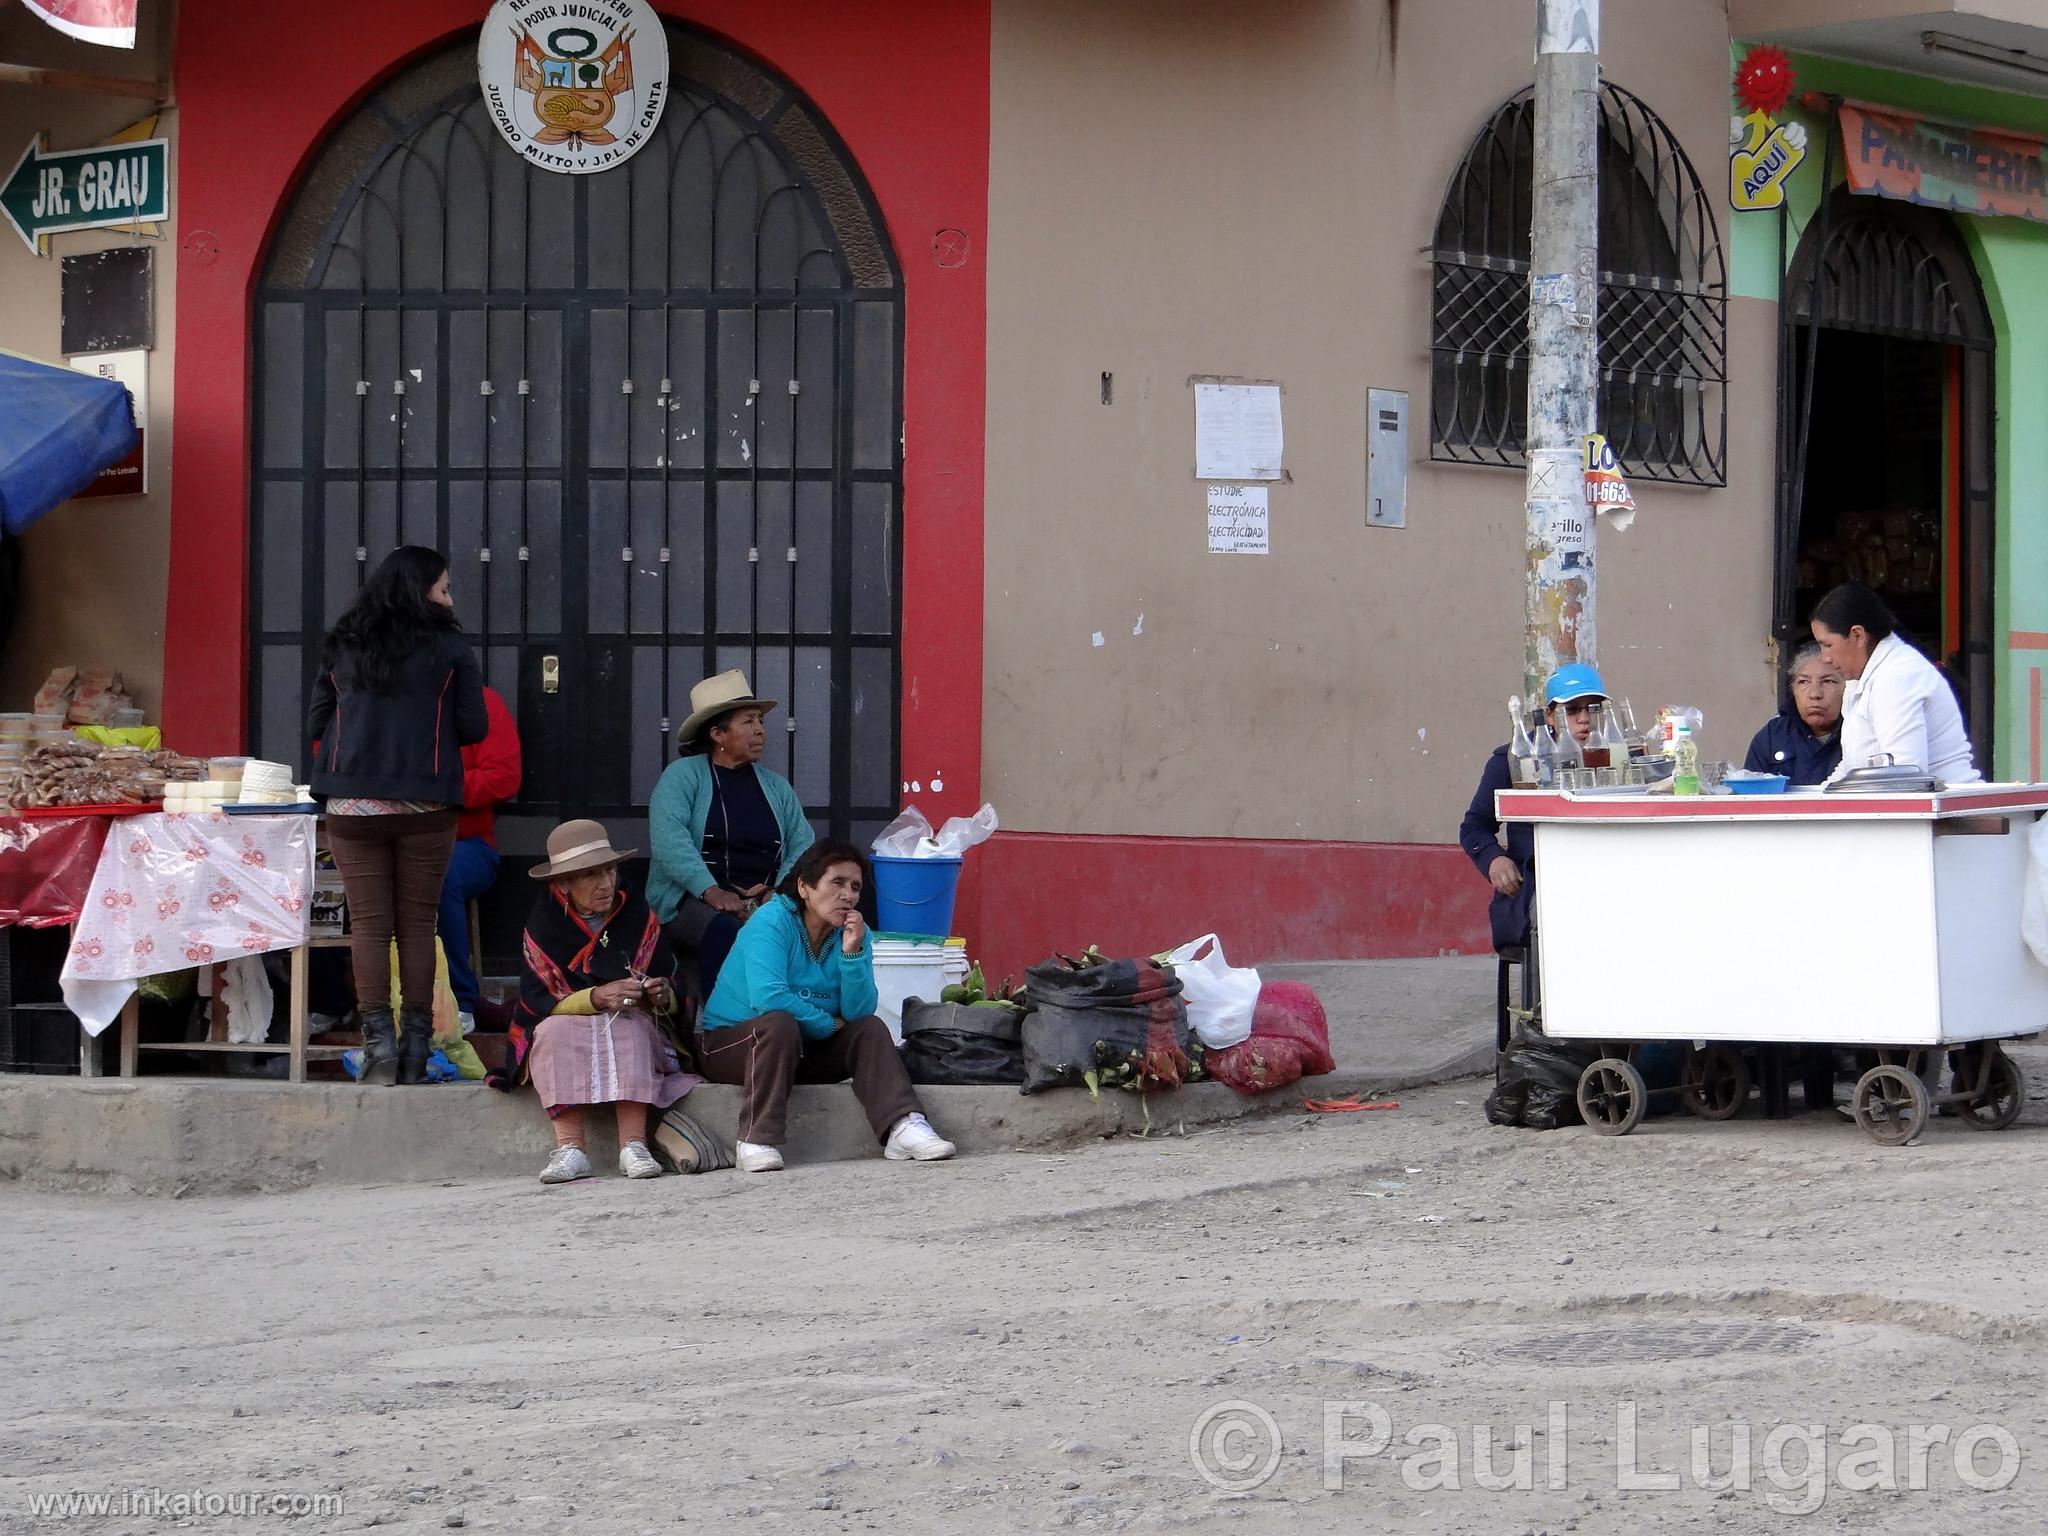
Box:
[328,811,459,1008]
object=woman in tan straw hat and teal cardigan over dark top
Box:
[647,670,815,997]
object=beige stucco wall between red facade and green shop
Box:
[978,0,1774,842]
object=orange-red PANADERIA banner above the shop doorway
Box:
[1841,102,2048,223]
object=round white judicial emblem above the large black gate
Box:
[477,0,668,176]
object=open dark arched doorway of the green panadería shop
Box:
[1776,190,1997,774]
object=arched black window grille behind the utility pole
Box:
[1430,82,1729,485]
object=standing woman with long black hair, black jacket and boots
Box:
[305,545,489,1085]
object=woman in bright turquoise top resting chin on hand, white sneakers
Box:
[696,842,954,1174]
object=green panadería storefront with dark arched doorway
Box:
[1731,27,2048,780]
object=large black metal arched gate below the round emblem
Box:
[250,29,901,852]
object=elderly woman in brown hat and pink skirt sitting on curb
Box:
[489,821,702,1184]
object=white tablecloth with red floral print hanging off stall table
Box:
[63,811,313,1034]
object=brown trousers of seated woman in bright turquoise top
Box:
[696,1014,924,1147]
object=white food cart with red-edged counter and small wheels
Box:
[1497,784,2048,1145]
